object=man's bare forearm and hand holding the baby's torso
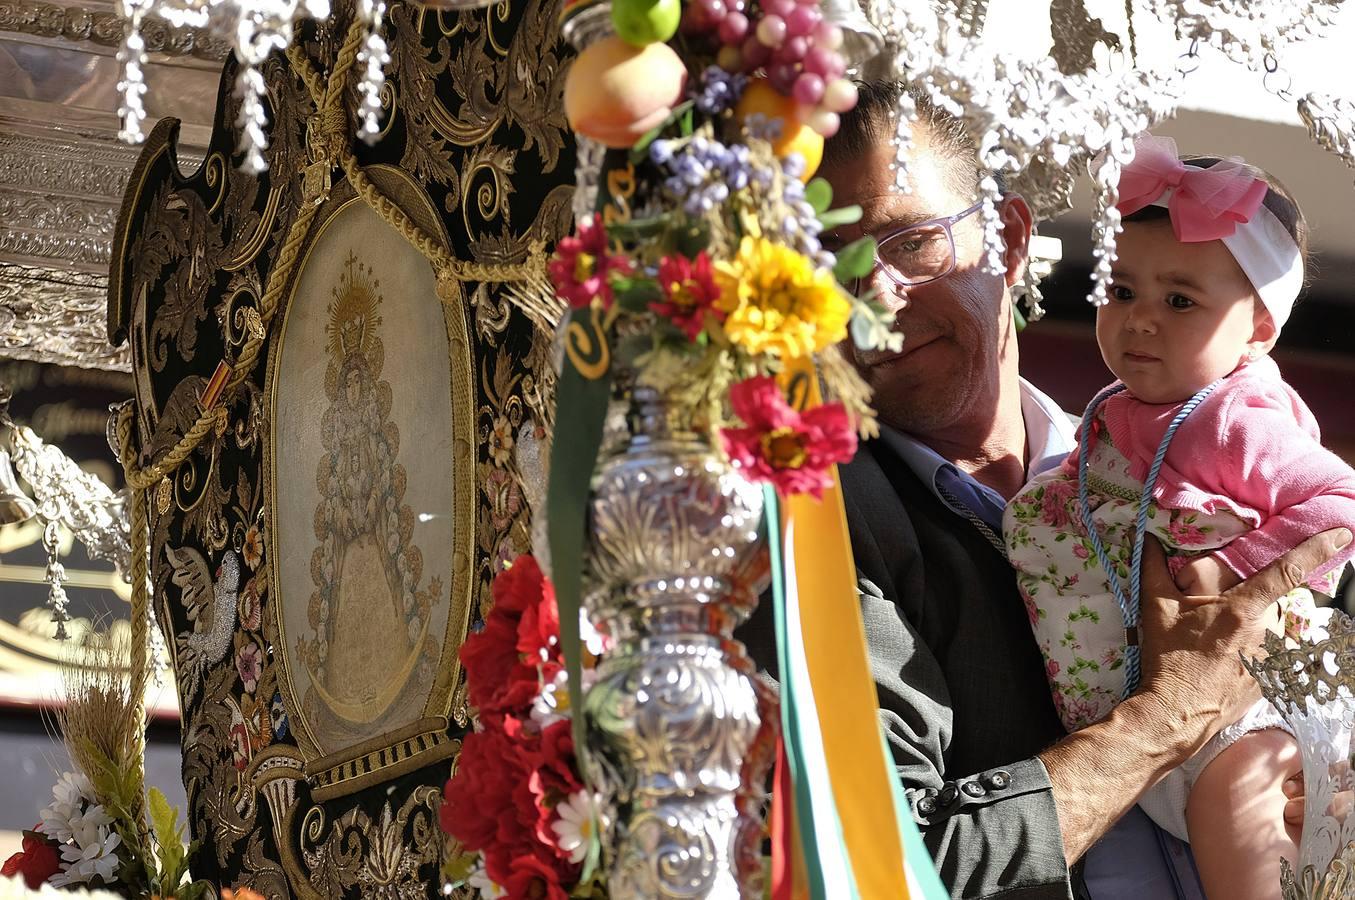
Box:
[1039,529,1351,862]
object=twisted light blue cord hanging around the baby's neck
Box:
[1077,378,1224,697]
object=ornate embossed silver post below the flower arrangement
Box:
[584,376,776,900]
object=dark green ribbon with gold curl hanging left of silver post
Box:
[546,308,611,782]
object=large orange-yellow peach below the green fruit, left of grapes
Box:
[565,35,687,146]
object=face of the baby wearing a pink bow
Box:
[1096,220,1270,403]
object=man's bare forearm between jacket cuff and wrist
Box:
[1039,694,1201,863]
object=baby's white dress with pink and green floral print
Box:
[1003,417,1248,731]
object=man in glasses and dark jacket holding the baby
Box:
[751,85,1350,900]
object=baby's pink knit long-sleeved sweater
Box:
[1064,356,1355,586]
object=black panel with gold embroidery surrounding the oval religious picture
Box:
[108,0,573,899]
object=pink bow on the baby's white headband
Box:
[1115,131,1267,244]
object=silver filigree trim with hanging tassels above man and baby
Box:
[860,0,1355,312]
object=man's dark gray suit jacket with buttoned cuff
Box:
[740,441,1085,900]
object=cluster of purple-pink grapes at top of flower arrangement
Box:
[682,0,856,137]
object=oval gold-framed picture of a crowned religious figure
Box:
[264,165,476,800]
